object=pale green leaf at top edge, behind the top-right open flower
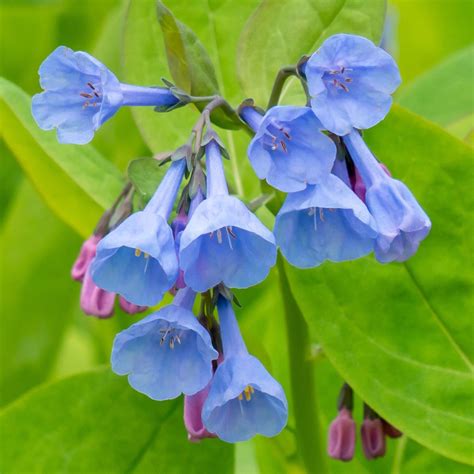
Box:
[238,0,385,105]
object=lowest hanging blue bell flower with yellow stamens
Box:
[202,297,288,443]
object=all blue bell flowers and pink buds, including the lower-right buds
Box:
[32,31,431,454]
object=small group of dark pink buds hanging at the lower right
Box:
[328,384,402,461]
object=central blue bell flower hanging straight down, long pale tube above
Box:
[179,141,276,292]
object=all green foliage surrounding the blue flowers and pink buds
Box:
[0,0,474,474]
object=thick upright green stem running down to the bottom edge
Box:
[278,255,327,474]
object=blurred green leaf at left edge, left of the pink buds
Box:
[0,180,80,405]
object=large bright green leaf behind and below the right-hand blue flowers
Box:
[287,107,474,463]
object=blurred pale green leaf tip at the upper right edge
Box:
[399,45,474,130]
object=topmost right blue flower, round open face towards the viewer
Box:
[304,34,401,135]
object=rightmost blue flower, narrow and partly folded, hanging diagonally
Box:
[344,130,431,263]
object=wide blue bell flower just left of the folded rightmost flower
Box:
[274,159,377,268]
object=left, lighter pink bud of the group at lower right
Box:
[328,408,356,461]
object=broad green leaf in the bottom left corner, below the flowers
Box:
[0,368,234,474]
